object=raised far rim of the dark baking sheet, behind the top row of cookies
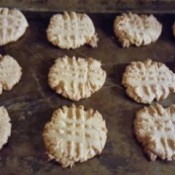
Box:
[0,0,175,13]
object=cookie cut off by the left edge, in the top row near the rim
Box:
[0,8,28,46]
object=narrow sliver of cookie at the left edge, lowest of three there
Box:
[0,106,11,149]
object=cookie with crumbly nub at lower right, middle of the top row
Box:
[47,12,98,49]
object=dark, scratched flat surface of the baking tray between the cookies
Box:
[0,12,175,175]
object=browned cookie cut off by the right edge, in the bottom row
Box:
[134,104,175,161]
